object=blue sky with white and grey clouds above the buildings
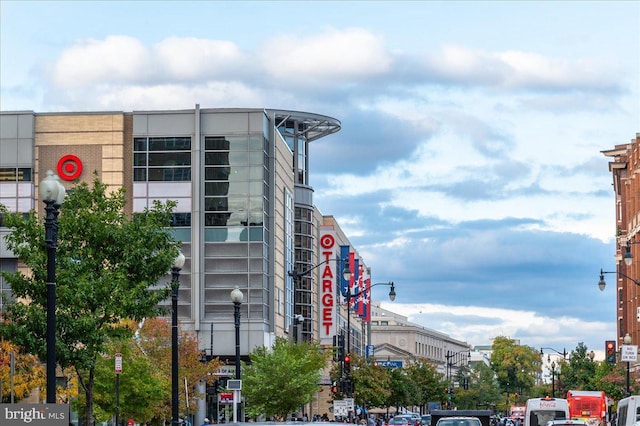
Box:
[0,0,640,357]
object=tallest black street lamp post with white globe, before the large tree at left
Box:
[40,170,66,404]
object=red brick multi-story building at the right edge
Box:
[602,133,640,345]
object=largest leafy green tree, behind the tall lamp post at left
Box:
[0,177,179,426]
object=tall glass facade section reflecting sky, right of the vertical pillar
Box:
[202,132,270,319]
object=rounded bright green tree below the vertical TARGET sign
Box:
[242,337,330,418]
